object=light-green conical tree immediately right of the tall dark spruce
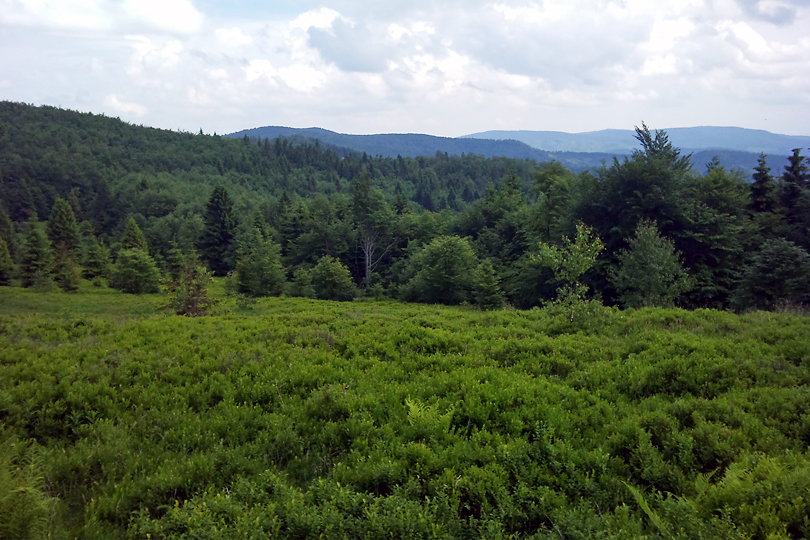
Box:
[234,227,285,296]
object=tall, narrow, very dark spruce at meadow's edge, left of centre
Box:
[199,186,237,276]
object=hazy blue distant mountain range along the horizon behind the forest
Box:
[227,126,810,172]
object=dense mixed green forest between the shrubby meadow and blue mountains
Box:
[0,102,810,310]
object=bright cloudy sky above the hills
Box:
[0,0,810,137]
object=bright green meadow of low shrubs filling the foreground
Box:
[0,286,810,539]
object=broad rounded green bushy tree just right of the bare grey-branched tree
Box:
[402,236,478,304]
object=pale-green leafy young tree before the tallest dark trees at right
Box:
[610,217,692,308]
